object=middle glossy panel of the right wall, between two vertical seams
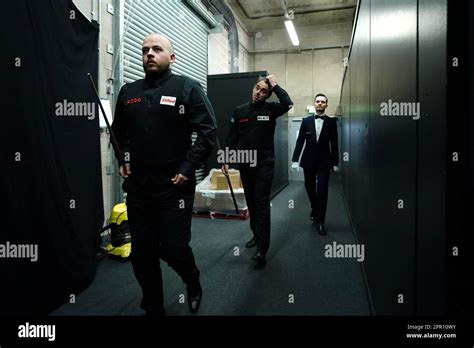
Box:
[368,0,417,314]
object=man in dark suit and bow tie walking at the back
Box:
[291,93,339,236]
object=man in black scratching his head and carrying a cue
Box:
[222,75,293,266]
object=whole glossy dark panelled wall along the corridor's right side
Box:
[341,0,449,315]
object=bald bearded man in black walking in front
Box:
[112,33,217,317]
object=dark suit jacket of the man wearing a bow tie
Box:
[292,115,339,168]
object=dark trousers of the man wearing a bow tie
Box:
[303,166,329,224]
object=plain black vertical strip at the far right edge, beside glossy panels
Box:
[445,0,474,315]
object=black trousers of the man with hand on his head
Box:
[240,158,275,254]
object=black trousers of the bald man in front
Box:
[127,182,199,312]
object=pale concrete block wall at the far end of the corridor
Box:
[254,22,352,117]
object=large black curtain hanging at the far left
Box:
[0,0,104,316]
